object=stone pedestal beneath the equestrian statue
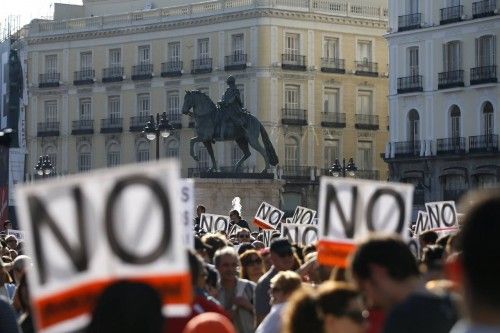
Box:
[194,174,285,227]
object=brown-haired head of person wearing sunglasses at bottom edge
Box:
[317,281,367,333]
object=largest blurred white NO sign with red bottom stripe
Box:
[16,161,192,332]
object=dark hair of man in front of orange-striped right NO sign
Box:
[351,236,419,281]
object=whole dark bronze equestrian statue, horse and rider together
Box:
[182,76,278,173]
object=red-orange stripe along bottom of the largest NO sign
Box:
[34,273,192,329]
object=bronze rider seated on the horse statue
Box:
[218,75,245,139]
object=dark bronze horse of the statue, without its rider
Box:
[182,90,278,173]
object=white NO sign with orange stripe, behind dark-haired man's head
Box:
[318,177,413,267]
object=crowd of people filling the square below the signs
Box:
[0,191,500,333]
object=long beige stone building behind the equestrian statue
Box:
[27,0,388,210]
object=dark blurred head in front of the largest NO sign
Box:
[87,281,163,333]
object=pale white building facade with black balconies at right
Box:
[386,0,500,213]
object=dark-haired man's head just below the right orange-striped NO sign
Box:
[350,236,419,309]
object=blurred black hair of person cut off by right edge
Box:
[461,190,500,309]
